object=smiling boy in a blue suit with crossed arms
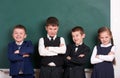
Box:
[8,25,34,78]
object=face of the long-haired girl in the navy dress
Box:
[99,31,112,45]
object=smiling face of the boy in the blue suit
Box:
[12,28,26,43]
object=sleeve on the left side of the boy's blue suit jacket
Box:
[8,44,23,61]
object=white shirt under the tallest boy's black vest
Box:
[38,35,66,56]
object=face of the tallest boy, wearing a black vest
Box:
[46,25,58,37]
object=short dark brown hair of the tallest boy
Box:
[46,17,59,26]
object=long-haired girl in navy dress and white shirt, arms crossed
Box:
[91,27,115,78]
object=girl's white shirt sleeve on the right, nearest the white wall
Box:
[99,46,115,62]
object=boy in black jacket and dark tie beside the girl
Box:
[64,26,90,78]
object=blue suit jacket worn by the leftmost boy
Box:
[8,41,34,75]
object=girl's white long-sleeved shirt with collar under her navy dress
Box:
[91,43,115,64]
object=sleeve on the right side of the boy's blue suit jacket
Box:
[19,41,34,55]
